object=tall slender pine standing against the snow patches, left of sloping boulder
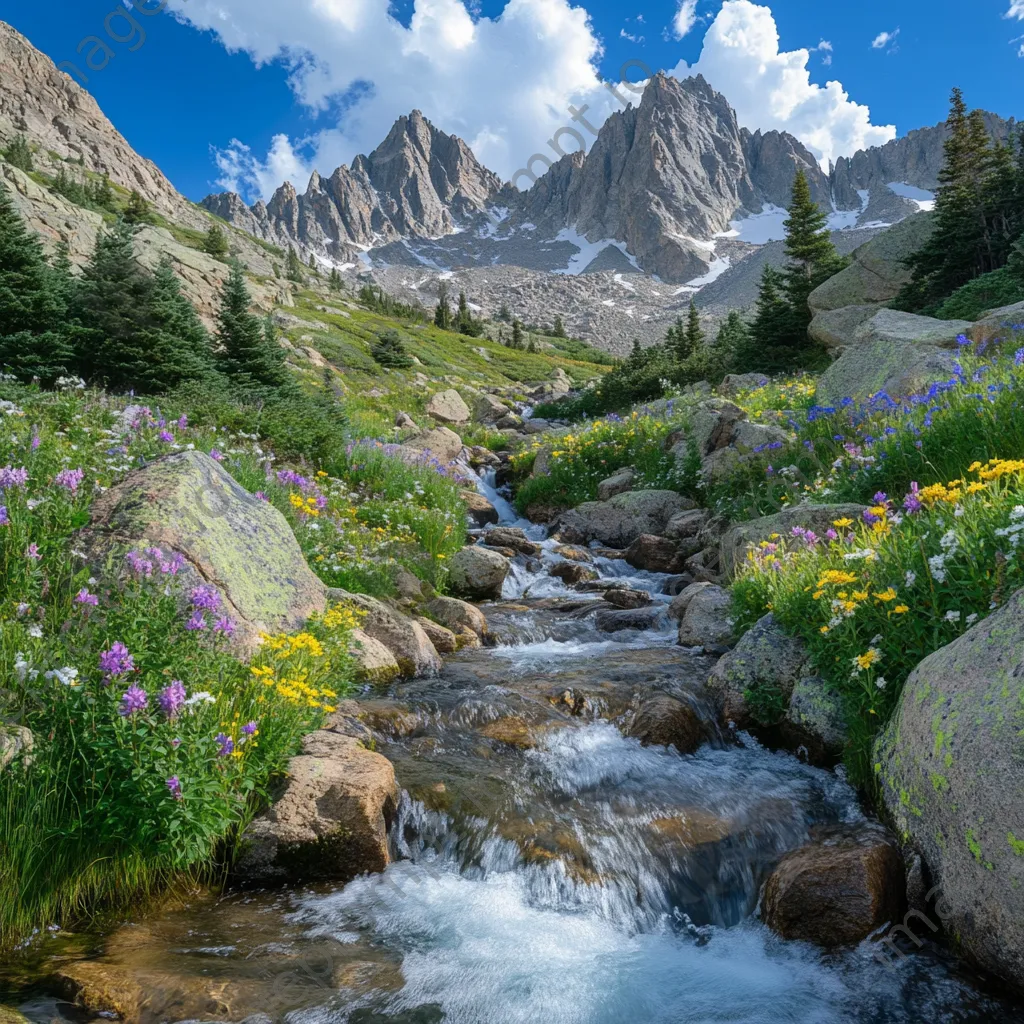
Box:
[782,170,846,335]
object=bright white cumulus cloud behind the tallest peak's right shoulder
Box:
[672,0,896,164]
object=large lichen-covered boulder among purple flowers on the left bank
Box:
[82,452,327,651]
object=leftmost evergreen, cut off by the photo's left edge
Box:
[0,184,73,384]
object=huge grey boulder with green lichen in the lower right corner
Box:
[874,591,1024,987]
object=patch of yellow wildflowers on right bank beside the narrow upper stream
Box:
[511,401,699,510]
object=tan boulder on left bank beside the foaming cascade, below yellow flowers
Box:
[234,729,398,883]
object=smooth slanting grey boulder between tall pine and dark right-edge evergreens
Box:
[808,213,934,313]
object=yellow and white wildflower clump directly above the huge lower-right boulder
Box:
[733,459,1024,781]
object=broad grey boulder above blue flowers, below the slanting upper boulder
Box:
[818,309,973,404]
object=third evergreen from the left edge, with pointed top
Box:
[134,255,213,394]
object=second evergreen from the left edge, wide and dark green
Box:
[72,220,154,390]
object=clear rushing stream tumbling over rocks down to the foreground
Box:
[4,471,1024,1024]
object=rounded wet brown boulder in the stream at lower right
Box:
[761,823,905,948]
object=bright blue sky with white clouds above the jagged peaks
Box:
[3,0,1024,199]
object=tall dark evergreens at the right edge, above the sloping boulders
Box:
[895,89,1024,312]
